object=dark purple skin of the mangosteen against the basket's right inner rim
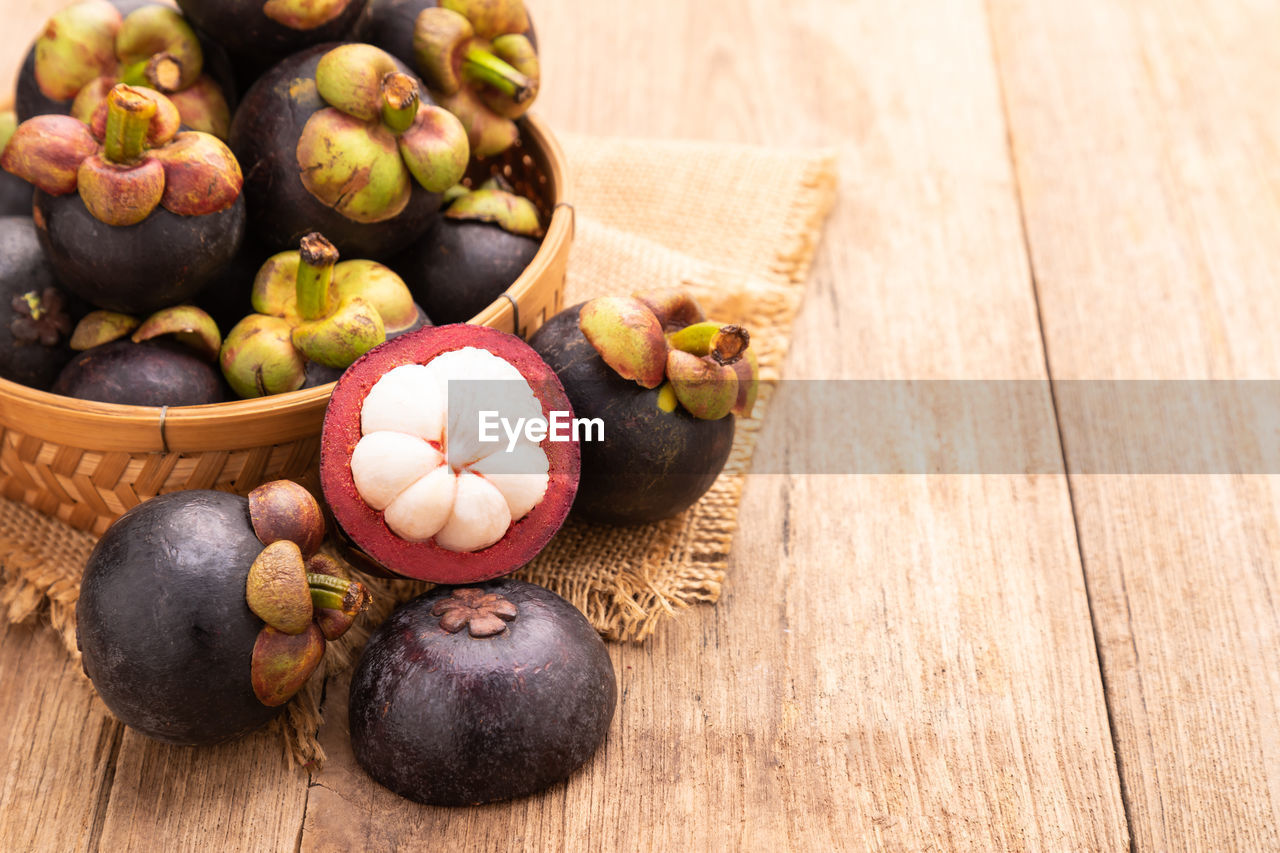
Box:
[389,216,541,323]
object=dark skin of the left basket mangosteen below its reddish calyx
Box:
[35,190,246,315]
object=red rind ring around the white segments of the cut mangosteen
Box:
[320,324,581,584]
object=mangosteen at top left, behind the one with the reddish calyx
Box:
[17,0,234,138]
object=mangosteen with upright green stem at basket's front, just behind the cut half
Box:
[219,233,429,397]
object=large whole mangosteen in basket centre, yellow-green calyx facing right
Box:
[232,44,470,260]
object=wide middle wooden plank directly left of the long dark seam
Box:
[303,0,1126,850]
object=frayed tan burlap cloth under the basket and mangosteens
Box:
[0,136,836,765]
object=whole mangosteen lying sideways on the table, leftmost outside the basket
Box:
[76,480,369,745]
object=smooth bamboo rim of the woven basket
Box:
[0,114,575,453]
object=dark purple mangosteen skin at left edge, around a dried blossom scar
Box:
[0,219,78,391]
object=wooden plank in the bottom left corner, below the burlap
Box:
[0,617,124,850]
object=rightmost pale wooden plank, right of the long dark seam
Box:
[992,0,1280,850]
